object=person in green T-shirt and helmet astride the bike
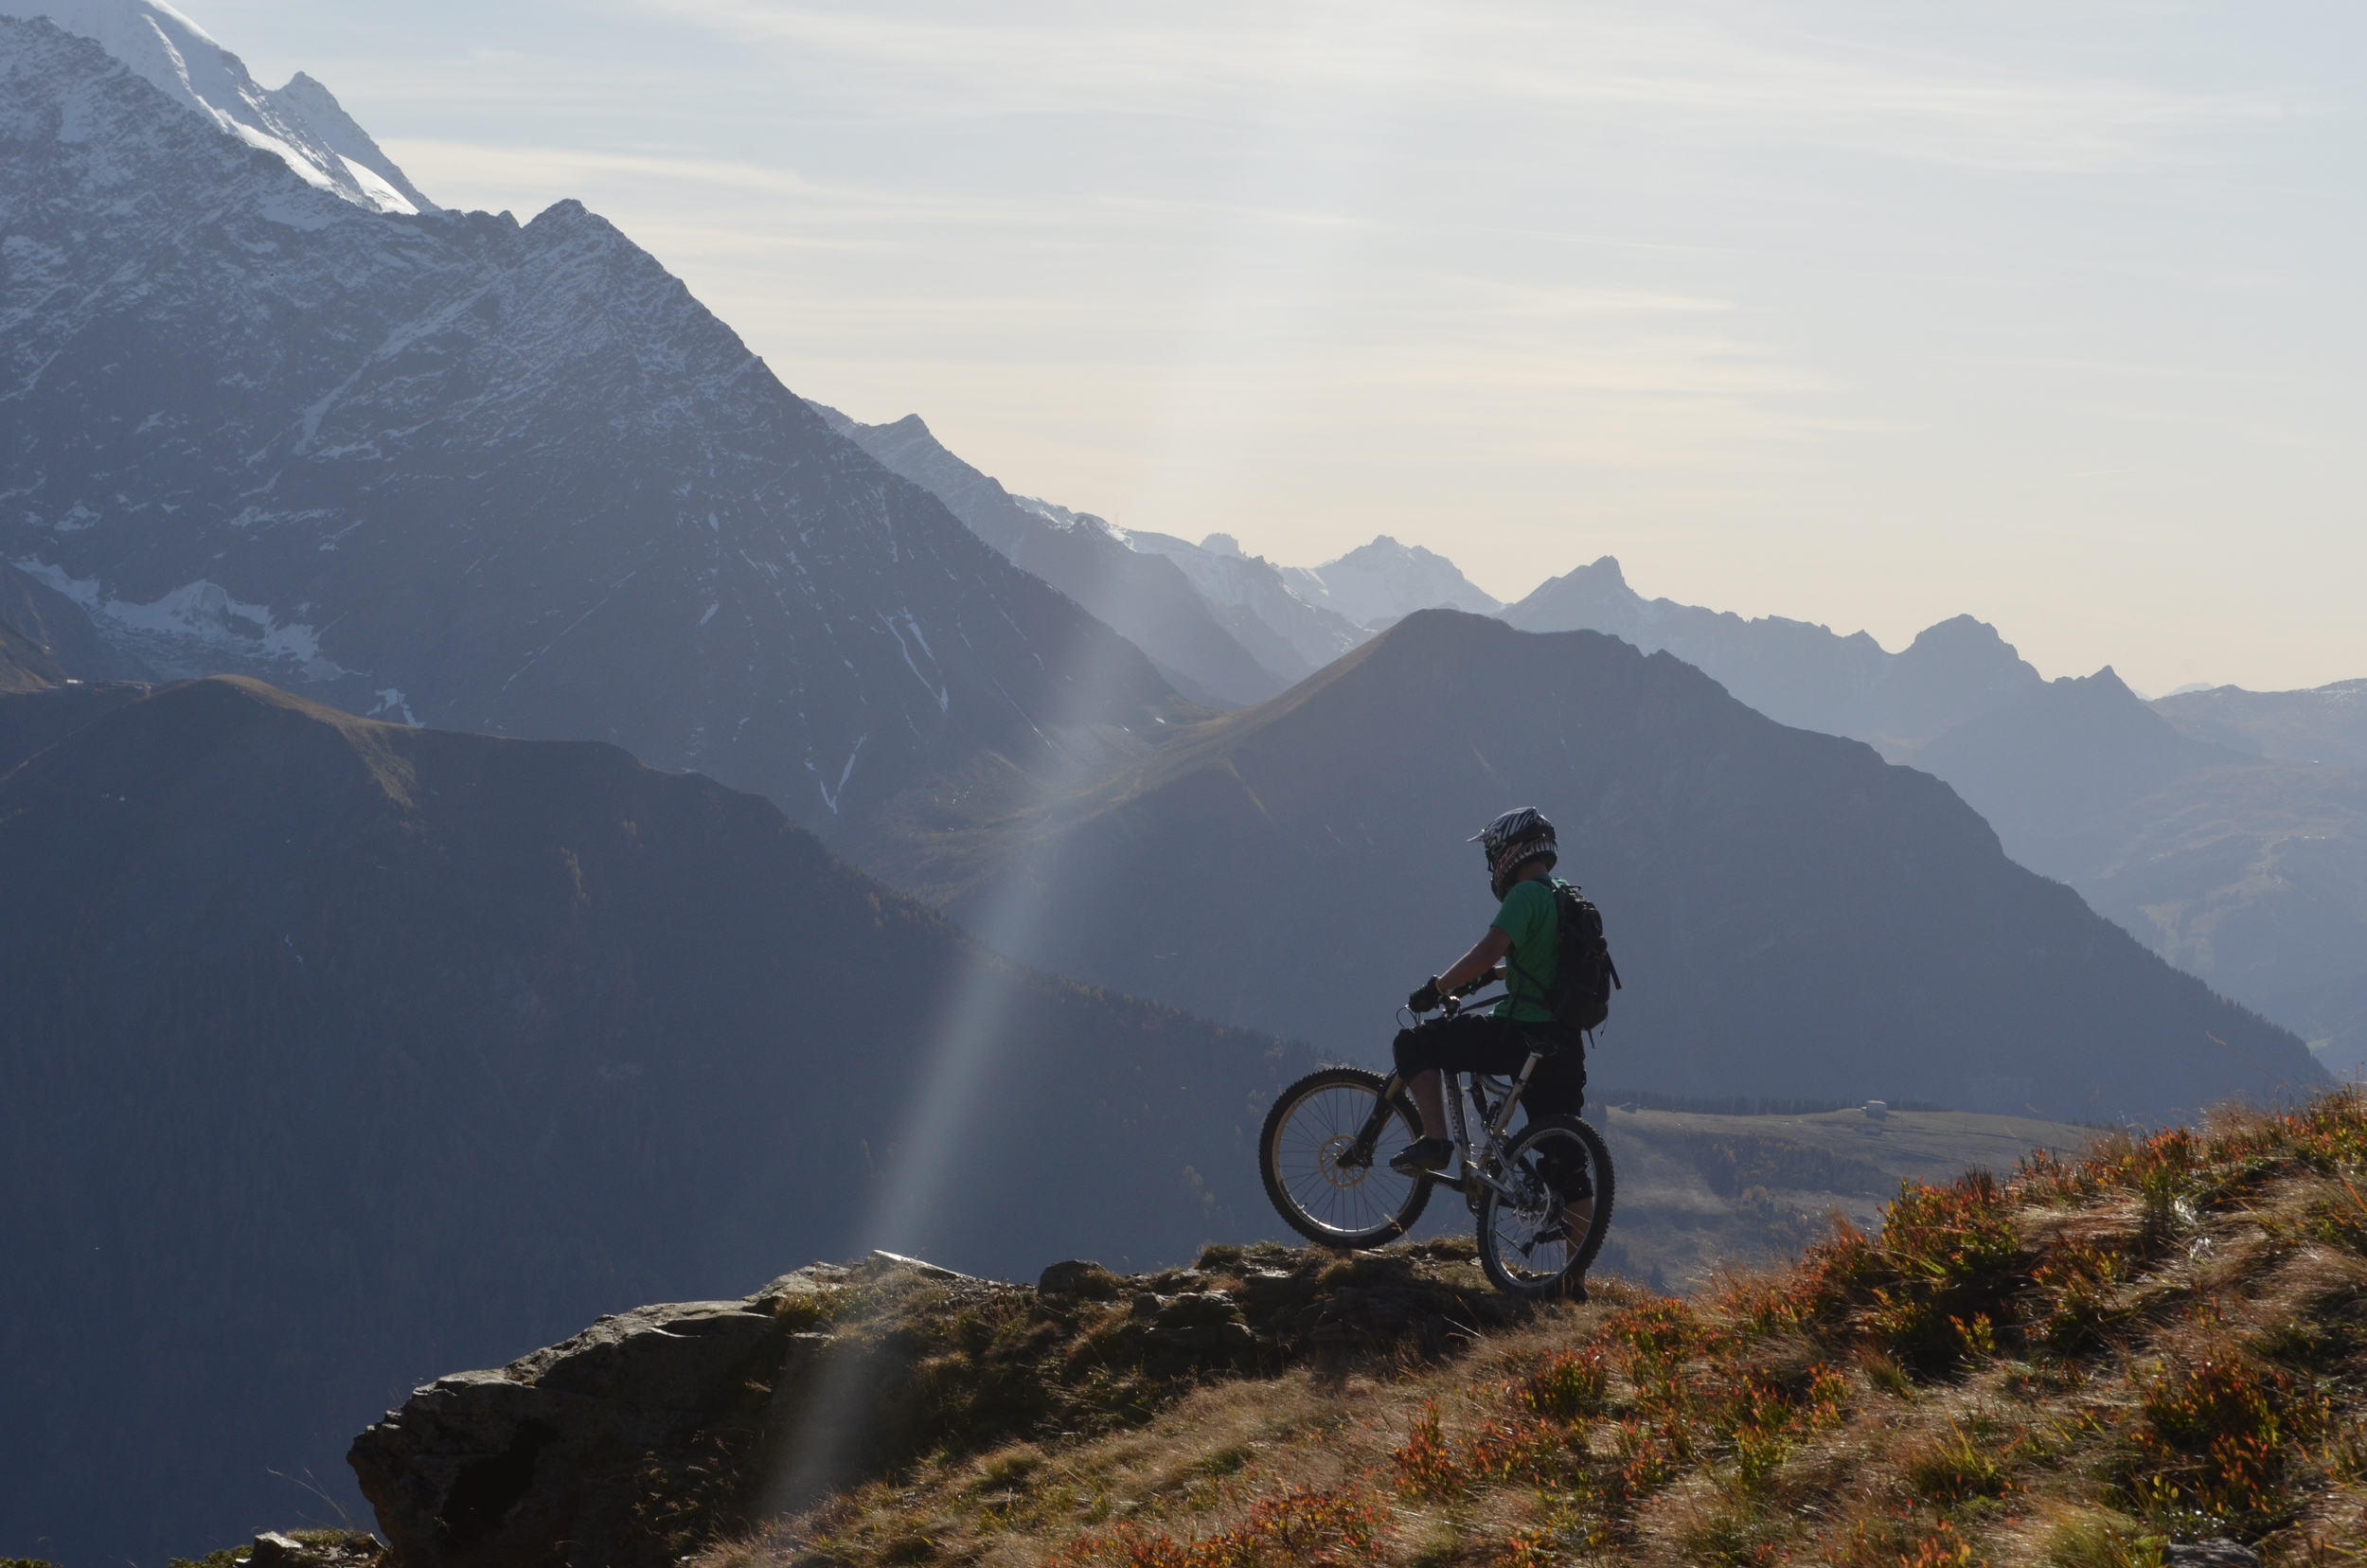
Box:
[1390,806,1595,1241]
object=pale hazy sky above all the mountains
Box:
[183,0,2367,691]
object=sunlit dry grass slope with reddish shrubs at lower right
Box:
[699,1092,2367,1568]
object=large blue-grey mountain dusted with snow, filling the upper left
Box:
[0,19,1174,843]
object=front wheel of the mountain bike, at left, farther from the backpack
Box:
[1257,1068,1430,1248]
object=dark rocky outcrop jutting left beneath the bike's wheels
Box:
[348,1243,1524,1568]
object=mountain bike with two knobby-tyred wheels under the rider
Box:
[1257,997,1612,1295]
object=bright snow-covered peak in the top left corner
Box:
[0,0,436,213]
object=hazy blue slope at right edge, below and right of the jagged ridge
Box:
[1911,668,2367,1073]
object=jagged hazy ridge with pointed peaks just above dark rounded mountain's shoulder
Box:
[1504,557,2038,756]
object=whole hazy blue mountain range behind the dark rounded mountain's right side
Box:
[1504,557,2367,1073]
